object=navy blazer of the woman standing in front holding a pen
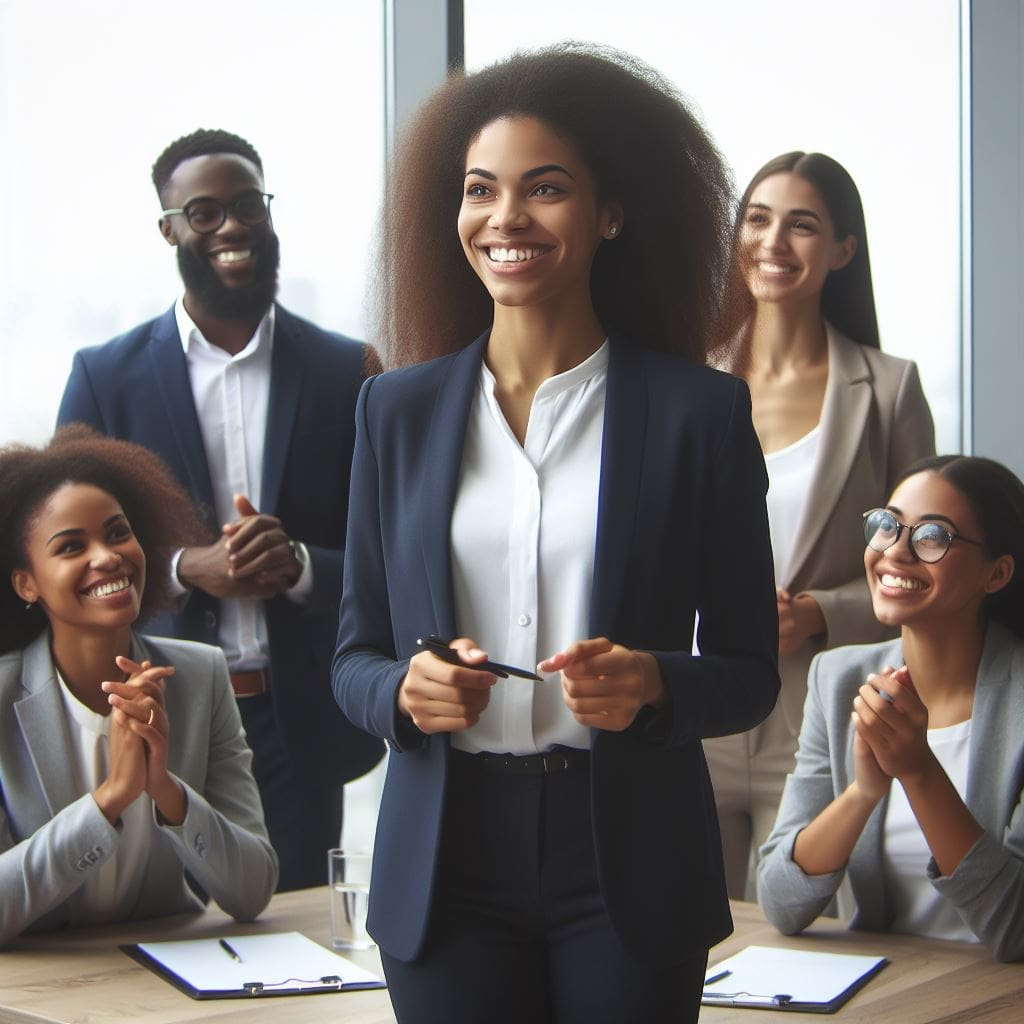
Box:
[333,336,779,965]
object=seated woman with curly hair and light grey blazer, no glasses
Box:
[0,424,278,946]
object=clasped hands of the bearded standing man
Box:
[178,495,302,599]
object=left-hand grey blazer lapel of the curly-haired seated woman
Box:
[14,631,80,816]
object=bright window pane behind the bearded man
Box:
[0,0,384,442]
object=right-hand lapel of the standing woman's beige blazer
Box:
[780,325,871,589]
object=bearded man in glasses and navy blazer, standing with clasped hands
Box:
[58,129,383,890]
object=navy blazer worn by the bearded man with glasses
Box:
[57,305,384,781]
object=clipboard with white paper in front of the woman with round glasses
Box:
[700,946,889,1014]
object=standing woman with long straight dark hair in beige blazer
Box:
[705,152,935,898]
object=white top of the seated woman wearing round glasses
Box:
[882,719,978,942]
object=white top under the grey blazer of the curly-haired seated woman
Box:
[57,673,154,924]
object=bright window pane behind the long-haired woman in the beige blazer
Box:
[465,0,962,451]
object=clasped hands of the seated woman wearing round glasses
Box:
[853,666,934,780]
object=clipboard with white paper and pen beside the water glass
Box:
[120,932,387,999]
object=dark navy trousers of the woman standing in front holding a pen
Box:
[382,752,708,1024]
